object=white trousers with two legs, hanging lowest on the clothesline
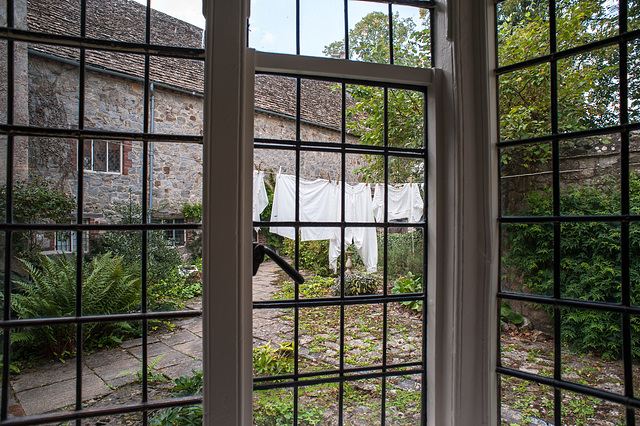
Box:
[329,183,378,272]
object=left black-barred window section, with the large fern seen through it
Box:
[0,0,204,425]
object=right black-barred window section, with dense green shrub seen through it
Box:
[494,0,640,425]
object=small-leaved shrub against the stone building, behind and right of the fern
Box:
[87,194,182,284]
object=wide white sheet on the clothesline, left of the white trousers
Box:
[270,174,340,241]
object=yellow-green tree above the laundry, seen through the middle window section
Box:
[324,12,431,182]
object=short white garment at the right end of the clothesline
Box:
[373,183,424,223]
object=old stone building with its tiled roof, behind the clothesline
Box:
[13,0,363,231]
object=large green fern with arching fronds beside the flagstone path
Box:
[11,253,141,357]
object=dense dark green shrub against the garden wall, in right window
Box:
[502,173,640,359]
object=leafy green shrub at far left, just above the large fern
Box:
[0,175,76,263]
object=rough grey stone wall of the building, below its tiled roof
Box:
[29,54,364,217]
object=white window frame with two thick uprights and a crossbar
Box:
[203,0,498,426]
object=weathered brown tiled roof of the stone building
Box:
[27,0,354,128]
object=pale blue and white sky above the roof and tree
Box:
[130,0,419,56]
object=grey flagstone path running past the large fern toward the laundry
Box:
[5,262,281,416]
